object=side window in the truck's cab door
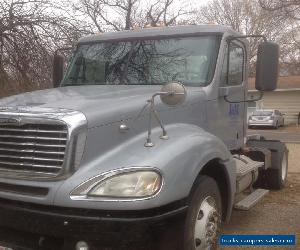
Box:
[221,42,245,86]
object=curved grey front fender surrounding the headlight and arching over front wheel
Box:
[54,124,235,215]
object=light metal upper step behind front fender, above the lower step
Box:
[233,155,264,179]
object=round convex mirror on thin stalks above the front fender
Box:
[160,82,186,106]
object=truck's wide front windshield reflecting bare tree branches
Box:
[62,36,219,86]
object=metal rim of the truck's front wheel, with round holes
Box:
[194,196,220,250]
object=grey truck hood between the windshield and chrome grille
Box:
[0,85,169,128]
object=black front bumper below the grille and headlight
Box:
[0,200,187,250]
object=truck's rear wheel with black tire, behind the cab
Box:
[266,151,288,190]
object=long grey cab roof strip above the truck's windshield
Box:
[78,25,241,43]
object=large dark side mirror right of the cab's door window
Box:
[255,42,279,91]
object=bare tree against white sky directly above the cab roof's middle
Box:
[74,0,193,32]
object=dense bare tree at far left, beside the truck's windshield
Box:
[0,0,82,95]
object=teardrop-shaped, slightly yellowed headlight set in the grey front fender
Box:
[71,170,162,198]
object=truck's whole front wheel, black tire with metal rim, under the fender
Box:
[183,176,222,250]
